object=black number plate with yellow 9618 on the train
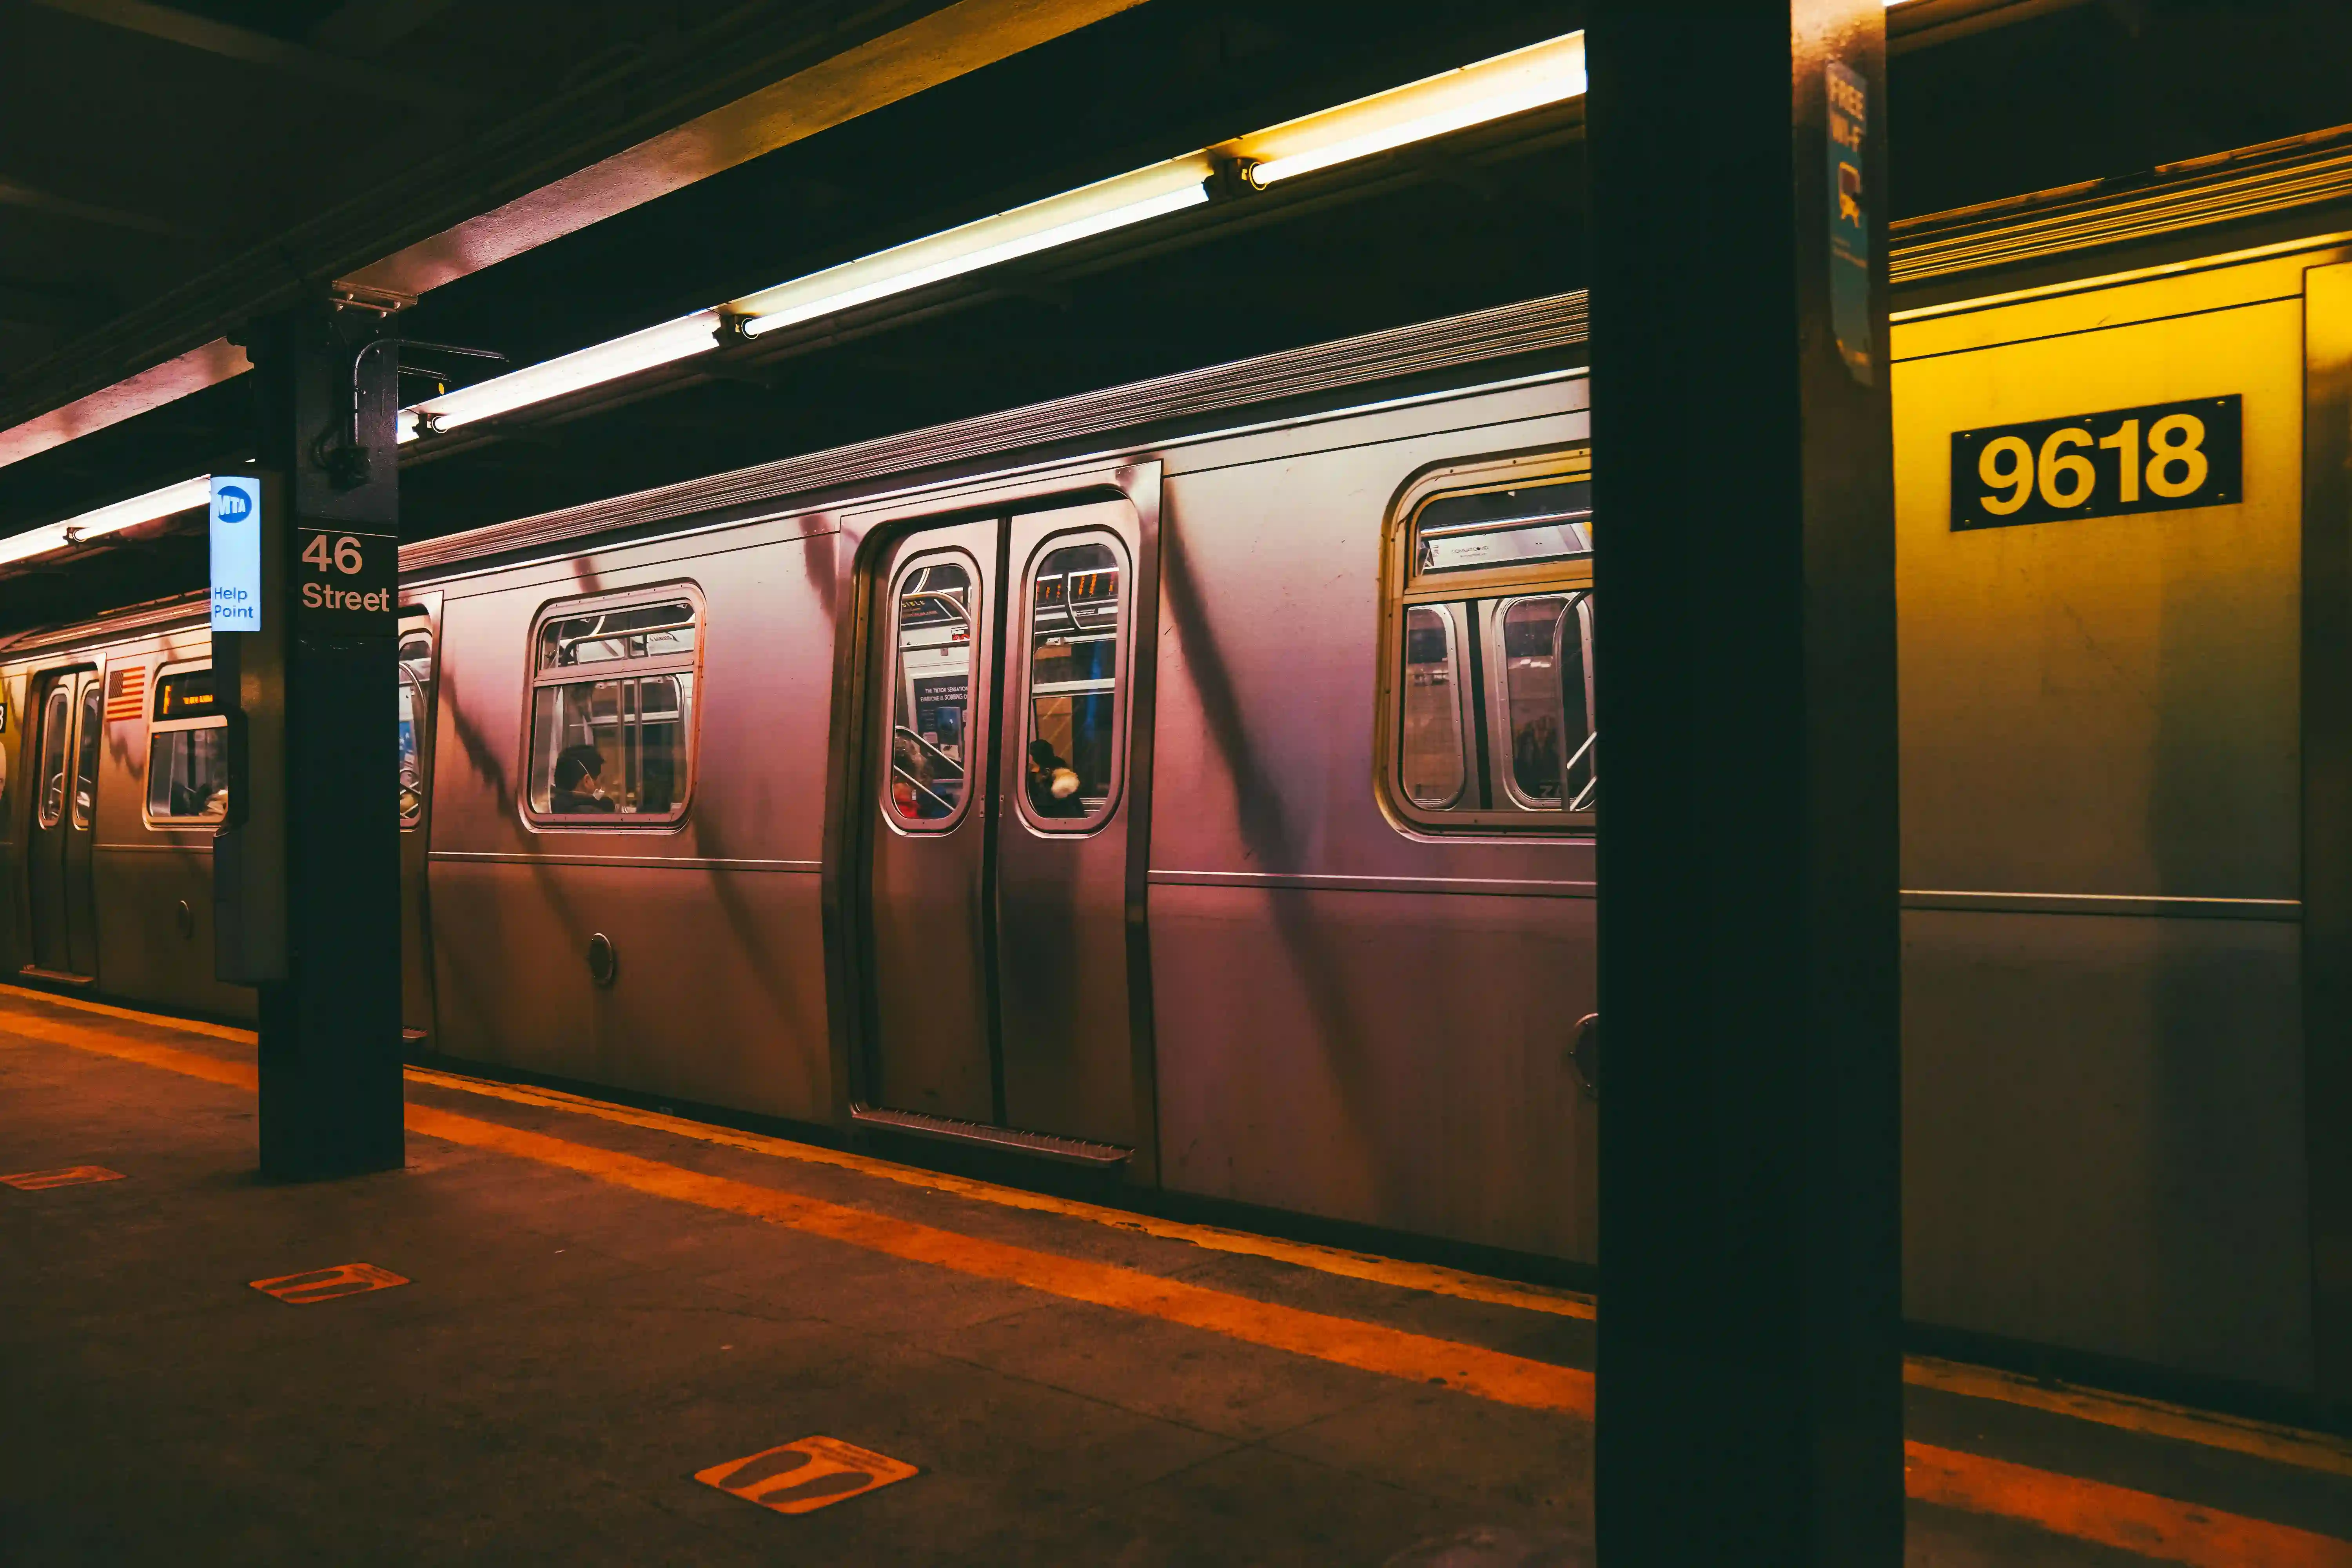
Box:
[1952,395,2244,531]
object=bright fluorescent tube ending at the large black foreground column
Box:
[1214,33,1585,188]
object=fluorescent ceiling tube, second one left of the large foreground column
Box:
[727,153,1216,339]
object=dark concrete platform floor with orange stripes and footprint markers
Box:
[0,987,2352,1568]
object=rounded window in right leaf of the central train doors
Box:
[1021,536,1127,832]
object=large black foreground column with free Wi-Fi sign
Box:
[1588,0,1903,1568]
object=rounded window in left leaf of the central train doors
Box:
[887,555,978,832]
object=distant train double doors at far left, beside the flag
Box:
[26,670,106,980]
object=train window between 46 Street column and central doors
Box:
[524,588,701,828]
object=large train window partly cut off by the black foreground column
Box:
[1383,454,1597,830]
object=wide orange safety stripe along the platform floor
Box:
[5,1013,2352,1568]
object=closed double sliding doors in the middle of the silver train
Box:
[856,501,1141,1161]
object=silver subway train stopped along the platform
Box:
[0,131,2352,1401]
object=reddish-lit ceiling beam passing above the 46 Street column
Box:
[0,0,1143,465]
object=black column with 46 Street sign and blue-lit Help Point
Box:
[212,303,405,1180]
